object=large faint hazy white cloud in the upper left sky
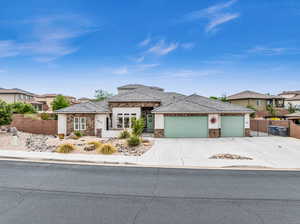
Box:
[0,15,96,62]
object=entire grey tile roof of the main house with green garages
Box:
[56,87,253,113]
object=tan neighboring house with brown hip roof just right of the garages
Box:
[227,90,284,111]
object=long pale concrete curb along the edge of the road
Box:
[0,156,300,171]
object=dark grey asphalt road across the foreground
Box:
[0,161,300,224]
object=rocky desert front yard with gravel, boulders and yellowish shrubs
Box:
[0,128,153,156]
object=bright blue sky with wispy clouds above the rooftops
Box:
[0,0,300,97]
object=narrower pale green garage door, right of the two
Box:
[221,116,245,137]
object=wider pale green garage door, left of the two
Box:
[164,116,208,138]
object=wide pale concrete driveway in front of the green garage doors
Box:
[138,136,300,168]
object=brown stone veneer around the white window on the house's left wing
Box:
[67,114,95,136]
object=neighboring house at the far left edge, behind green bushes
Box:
[0,88,44,111]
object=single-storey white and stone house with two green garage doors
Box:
[55,85,253,138]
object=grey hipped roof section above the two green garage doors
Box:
[152,94,253,113]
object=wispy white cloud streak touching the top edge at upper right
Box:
[185,0,240,32]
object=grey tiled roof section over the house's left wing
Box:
[55,100,109,113]
